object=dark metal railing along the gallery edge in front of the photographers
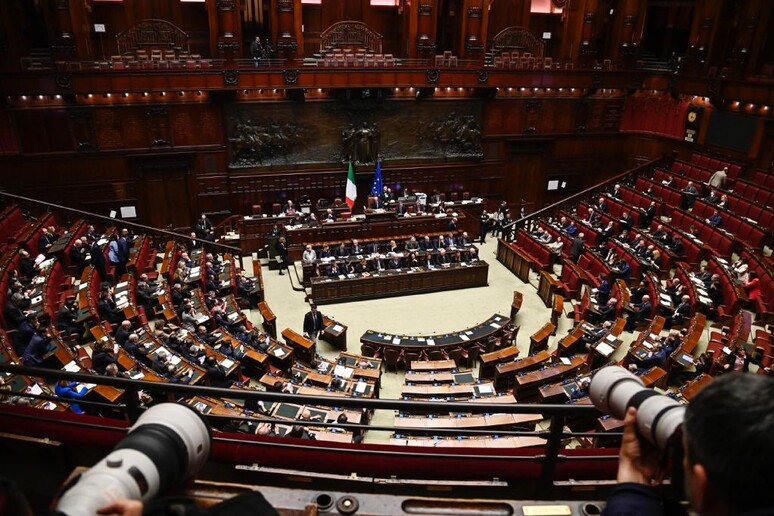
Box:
[0,364,621,497]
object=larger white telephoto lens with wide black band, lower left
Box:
[56,403,212,516]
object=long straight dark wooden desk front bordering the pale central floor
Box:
[312,261,489,305]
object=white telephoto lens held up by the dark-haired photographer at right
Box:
[589,366,685,450]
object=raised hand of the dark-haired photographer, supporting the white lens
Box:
[618,408,663,486]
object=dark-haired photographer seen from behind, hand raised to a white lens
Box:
[604,374,774,516]
